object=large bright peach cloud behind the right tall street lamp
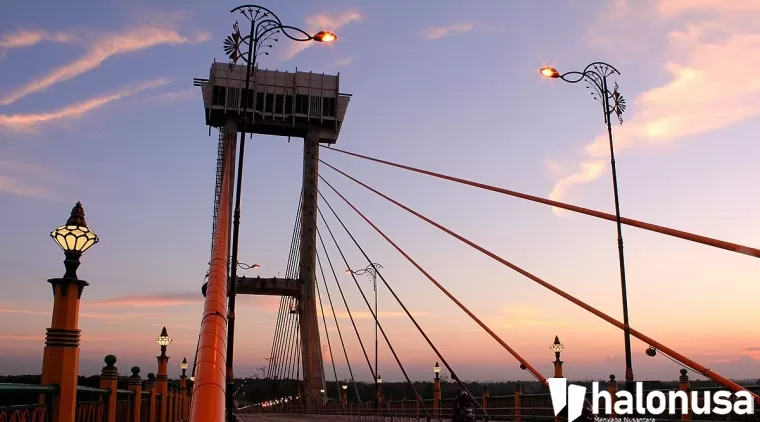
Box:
[551,0,760,212]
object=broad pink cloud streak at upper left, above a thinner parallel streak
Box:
[0,26,209,105]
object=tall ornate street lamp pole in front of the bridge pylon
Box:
[224,5,337,422]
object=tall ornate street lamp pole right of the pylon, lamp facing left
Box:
[540,62,634,391]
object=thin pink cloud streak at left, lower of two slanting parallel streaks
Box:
[0,79,170,131]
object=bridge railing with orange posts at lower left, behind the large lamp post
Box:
[0,352,190,422]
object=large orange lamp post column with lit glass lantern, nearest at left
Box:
[40,202,98,422]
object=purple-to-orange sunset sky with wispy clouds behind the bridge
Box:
[0,0,760,381]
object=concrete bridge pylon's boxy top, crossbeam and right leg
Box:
[194,57,351,408]
